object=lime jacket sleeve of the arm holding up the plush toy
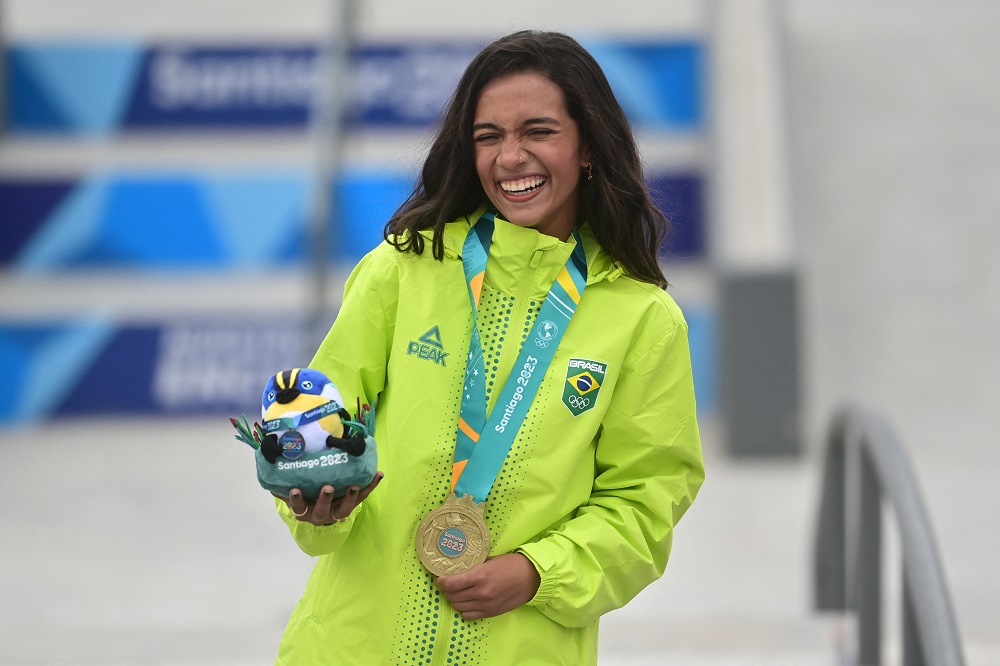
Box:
[276,247,398,557]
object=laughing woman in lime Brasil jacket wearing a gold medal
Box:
[277,32,704,665]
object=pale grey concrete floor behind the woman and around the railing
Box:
[0,417,1000,666]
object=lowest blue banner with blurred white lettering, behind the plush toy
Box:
[0,304,716,430]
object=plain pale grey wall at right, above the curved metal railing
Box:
[787,0,1000,453]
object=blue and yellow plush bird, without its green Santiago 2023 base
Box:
[260,368,365,463]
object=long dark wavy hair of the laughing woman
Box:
[383,30,670,288]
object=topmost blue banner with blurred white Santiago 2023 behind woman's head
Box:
[4,40,703,135]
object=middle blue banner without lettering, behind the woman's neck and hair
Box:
[0,171,704,274]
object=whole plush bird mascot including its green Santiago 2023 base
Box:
[229,368,378,500]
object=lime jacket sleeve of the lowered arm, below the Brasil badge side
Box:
[519,319,705,627]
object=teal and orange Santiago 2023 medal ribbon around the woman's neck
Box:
[451,210,587,503]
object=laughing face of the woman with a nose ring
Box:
[472,72,590,240]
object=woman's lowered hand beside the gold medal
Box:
[437,553,542,620]
